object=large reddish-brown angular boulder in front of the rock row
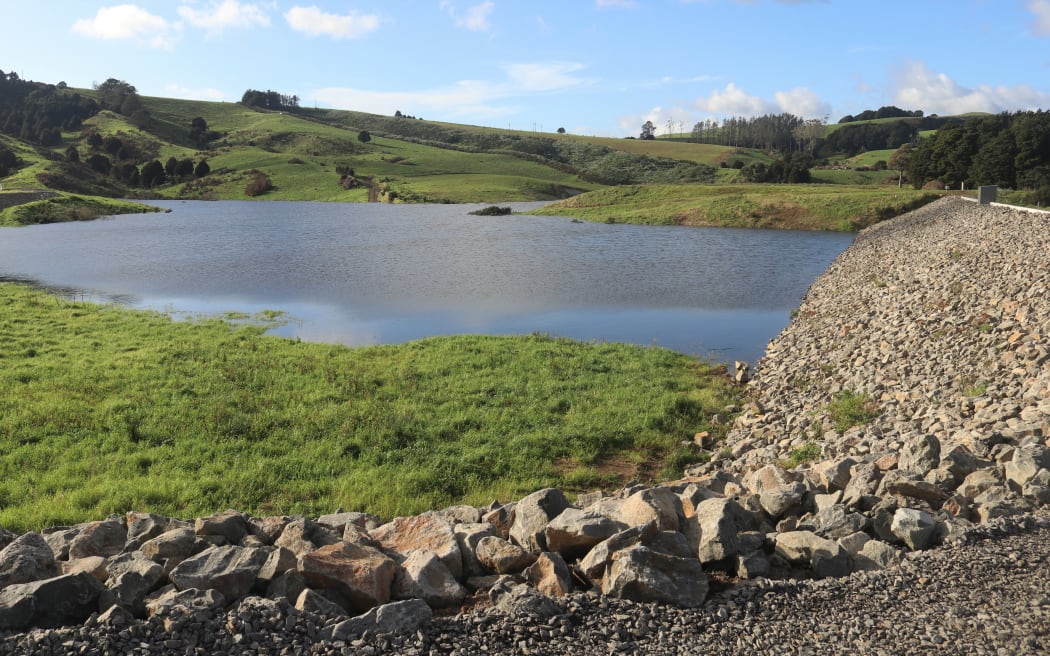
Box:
[298,543,397,612]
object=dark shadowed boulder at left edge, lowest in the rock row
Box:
[0,572,104,631]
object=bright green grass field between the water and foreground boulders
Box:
[0,284,737,530]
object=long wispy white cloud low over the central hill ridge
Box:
[308,62,588,118]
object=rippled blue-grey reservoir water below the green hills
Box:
[0,202,853,362]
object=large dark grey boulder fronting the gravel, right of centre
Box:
[602,545,708,608]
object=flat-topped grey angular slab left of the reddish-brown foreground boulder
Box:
[169,545,270,601]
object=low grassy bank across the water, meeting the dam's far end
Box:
[532,185,940,231]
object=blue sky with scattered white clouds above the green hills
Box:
[0,0,1050,136]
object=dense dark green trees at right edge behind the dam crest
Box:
[907,110,1050,198]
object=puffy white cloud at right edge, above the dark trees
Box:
[894,62,1050,114]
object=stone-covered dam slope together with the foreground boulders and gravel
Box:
[0,199,1050,654]
